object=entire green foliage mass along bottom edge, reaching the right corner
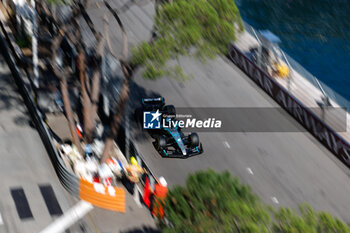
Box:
[159,170,350,233]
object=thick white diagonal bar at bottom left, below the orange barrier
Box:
[41,200,94,233]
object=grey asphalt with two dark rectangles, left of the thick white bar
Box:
[0,56,83,233]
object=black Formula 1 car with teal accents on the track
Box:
[135,97,203,158]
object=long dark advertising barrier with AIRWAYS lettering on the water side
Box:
[228,44,350,168]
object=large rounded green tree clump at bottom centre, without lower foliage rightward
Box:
[160,170,270,233]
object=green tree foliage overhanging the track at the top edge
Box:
[131,0,243,79]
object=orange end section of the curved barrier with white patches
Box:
[79,179,125,213]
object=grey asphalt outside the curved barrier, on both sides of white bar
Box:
[0,55,154,233]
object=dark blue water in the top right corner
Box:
[236,0,350,100]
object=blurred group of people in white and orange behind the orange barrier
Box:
[59,140,168,218]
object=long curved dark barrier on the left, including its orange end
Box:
[0,33,129,212]
